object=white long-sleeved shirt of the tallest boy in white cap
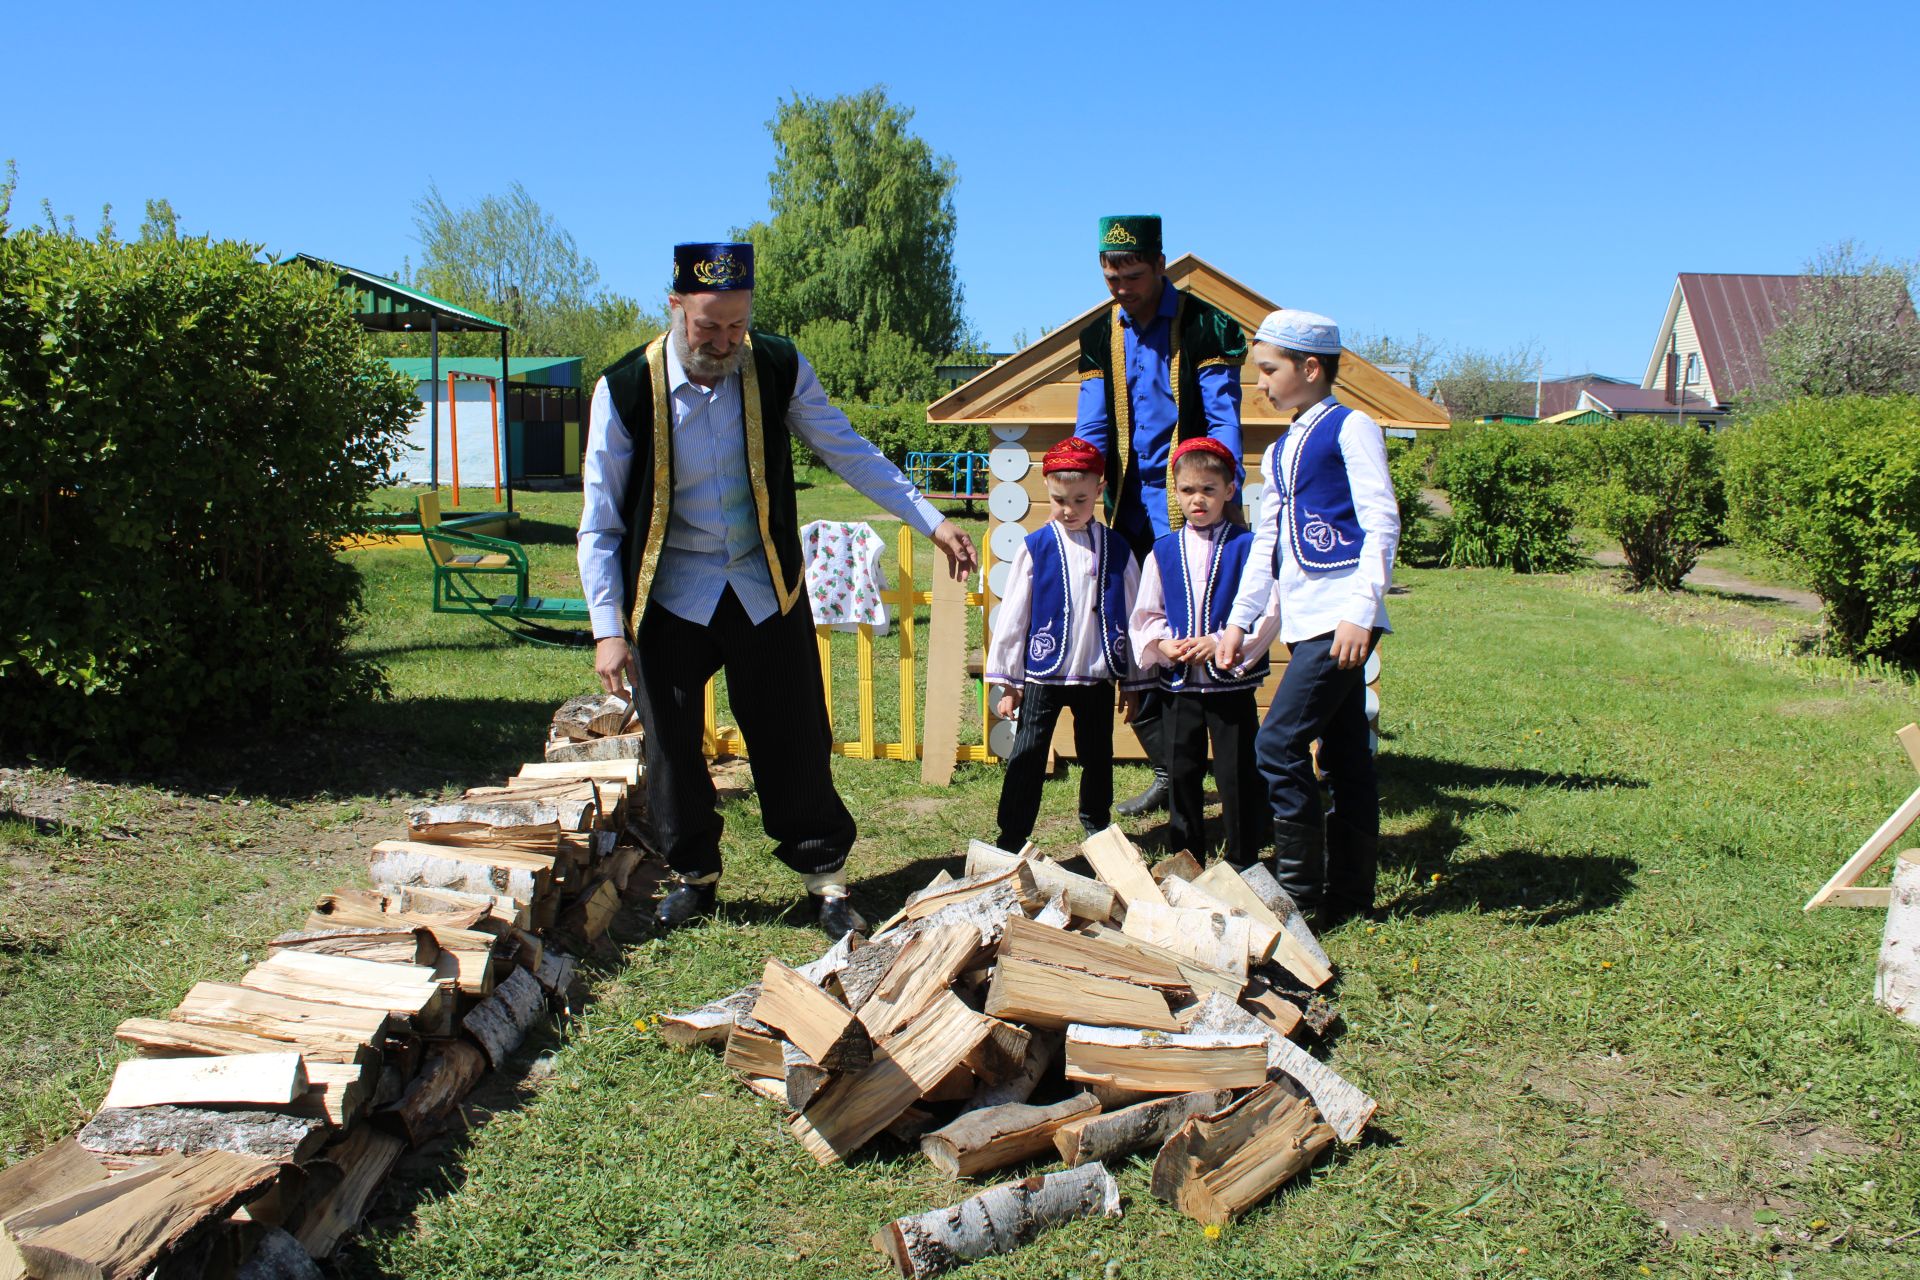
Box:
[1229,401,1400,645]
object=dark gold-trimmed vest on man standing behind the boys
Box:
[1079,290,1246,530]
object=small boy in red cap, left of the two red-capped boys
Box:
[985,436,1139,850]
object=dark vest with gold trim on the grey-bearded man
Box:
[607,330,806,639]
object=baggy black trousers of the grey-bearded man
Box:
[636,587,856,875]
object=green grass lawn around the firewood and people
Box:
[0,482,1920,1280]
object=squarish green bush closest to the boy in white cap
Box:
[1434,422,1580,574]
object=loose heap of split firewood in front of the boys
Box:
[660,827,1375,1276]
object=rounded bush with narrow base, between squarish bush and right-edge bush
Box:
[1565,418,1726,591]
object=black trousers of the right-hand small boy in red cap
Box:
[1162,689,1267,867]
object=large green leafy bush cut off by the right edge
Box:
[1720,395,1920,666]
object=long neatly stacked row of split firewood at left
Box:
[0,697,643,1280]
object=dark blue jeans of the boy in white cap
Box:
[1254,629,1380,837]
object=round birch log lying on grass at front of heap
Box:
[874,1165,1119,1280]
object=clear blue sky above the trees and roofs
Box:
[0,0,1920,378]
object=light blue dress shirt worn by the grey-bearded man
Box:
[580,340,945,639]
